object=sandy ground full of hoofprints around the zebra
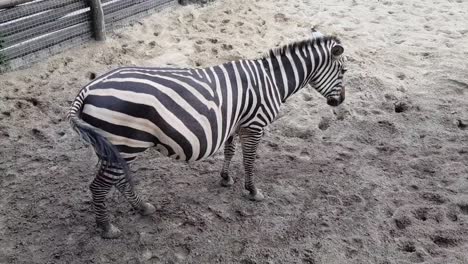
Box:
[0,0,468,264]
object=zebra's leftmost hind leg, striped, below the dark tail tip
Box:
[89,165,121,238]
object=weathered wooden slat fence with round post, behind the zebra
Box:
[0,0,180,68]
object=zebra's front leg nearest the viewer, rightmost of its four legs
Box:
[239,128,264,201]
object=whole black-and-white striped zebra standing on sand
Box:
[67,33,346,238]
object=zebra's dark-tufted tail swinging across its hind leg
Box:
[68,111,133,185]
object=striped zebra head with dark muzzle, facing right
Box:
[309,30,346,106]
